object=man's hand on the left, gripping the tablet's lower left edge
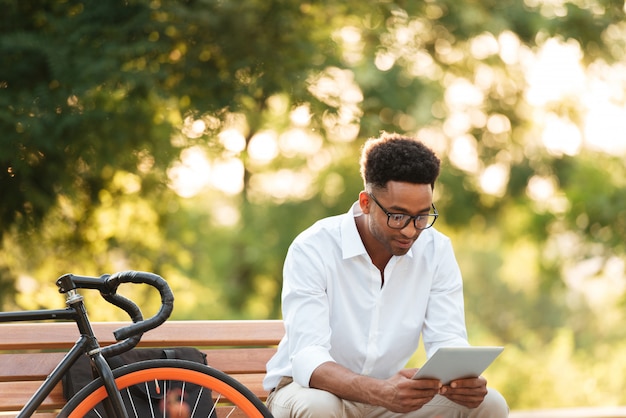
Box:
[380,370,441,413]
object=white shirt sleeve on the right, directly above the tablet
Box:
[422,238,469,357]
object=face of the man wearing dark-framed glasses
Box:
[360,181,433,255]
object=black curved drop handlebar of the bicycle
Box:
[57,271,174,357]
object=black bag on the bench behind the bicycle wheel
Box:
[62,347,216,418]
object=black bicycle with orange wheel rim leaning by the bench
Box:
[0,271,272,418]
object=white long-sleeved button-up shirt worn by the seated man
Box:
[263,202,468,390]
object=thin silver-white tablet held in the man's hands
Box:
[413,347,504,385]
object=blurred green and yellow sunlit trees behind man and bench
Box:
[0,0,626,409]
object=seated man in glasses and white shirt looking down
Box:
[264,134,508,418]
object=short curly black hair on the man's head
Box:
[360,132,440,189]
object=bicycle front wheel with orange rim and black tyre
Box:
[59,359,272,418]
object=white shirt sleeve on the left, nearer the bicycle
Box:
[282,237,335,387]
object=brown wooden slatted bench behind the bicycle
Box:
[0,320,284,418]
